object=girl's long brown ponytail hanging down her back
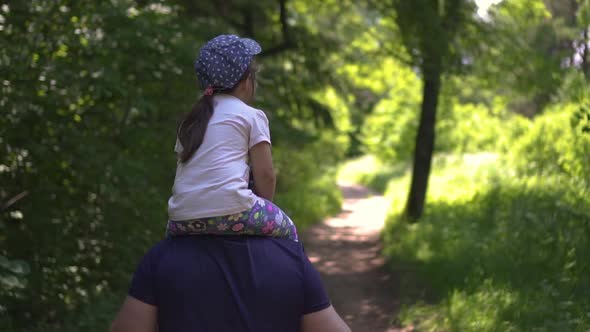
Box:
[177,94,213,163]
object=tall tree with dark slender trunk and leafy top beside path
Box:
[378,0,473,221]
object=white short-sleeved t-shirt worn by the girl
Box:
[168,94,270,221]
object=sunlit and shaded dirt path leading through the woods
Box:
[303,184,407,332]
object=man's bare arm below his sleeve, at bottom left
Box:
[111,296,158,332]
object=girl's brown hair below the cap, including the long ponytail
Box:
[177,62,258,163]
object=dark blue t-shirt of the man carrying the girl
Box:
[129,235,330,332]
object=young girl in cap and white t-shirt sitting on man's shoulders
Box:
[166,35,297,241]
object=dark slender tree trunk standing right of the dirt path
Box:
[405,59,441,222]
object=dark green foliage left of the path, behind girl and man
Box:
[0,0,348,331]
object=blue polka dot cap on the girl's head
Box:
[195,35,262,89]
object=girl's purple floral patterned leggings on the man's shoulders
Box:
[166,197,298,242]
